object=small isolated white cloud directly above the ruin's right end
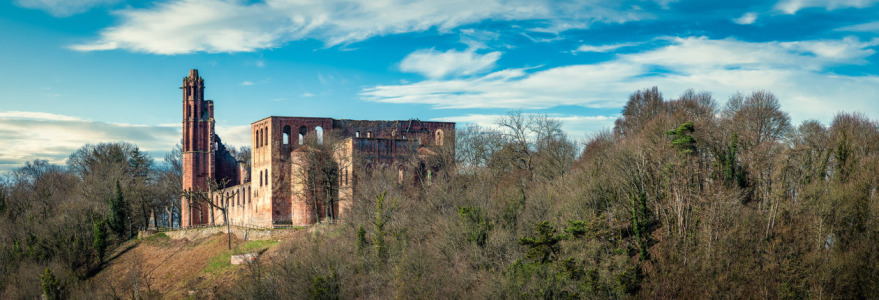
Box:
[400,49,501,78]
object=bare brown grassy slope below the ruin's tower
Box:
[89,231,299,298]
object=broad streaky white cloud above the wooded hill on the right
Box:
[361,38,879,125]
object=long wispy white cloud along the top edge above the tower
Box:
[71,0,648,54]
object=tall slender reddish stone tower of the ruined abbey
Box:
[180,69,216,226]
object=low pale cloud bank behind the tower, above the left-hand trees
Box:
[0,111,250,171]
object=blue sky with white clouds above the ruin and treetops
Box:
[0,0,879,170]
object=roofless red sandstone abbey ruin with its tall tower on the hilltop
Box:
[181,70,455,227]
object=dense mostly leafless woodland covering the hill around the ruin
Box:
[0,87,879,299]
